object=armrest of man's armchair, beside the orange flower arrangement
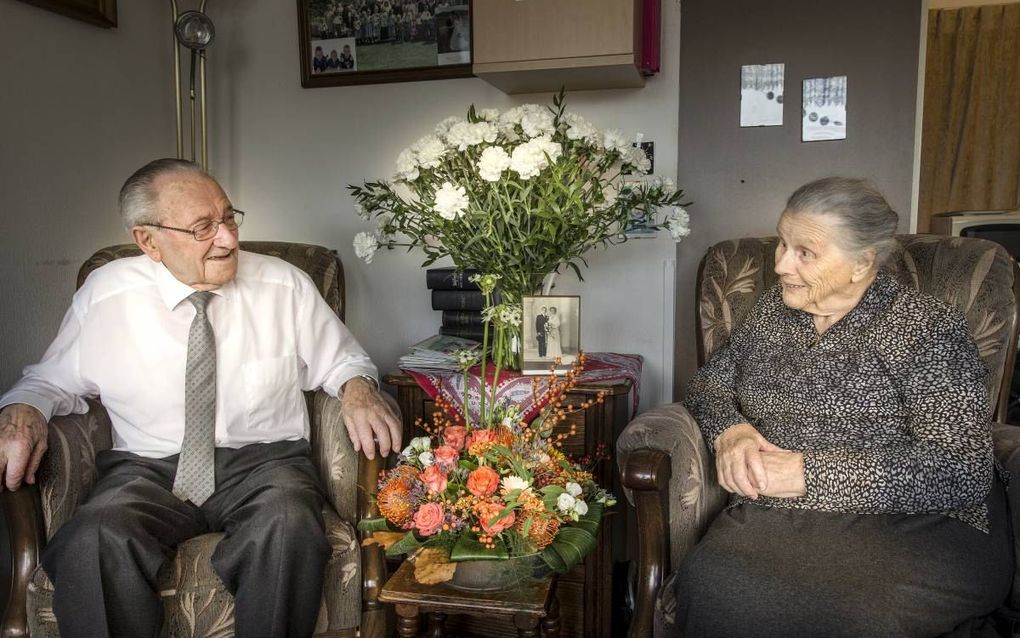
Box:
[312,390,400,636]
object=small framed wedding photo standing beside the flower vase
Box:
[521,295,580,375]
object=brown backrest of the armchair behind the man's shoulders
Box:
[78,242,345,321]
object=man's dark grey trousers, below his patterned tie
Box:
[42,440,329,638]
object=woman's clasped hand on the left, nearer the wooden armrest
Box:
[715,423,783,499]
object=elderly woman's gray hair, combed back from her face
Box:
[786,178,900,266]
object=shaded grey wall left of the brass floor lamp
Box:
[0,0,174,391]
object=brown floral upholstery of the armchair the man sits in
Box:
[28,242,375,638]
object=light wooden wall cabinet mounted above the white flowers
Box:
[471,0,644,93]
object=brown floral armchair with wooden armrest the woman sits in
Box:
[617,235,1020,638]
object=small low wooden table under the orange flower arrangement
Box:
[379,560,560,638]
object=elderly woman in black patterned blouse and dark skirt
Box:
[677,178,1013,637]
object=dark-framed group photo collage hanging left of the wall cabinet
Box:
[298,0,472,89]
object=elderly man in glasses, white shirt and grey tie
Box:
[0,159,400,638]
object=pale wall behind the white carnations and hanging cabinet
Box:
[209,0,685,406]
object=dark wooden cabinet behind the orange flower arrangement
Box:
[384,373,630,638]
